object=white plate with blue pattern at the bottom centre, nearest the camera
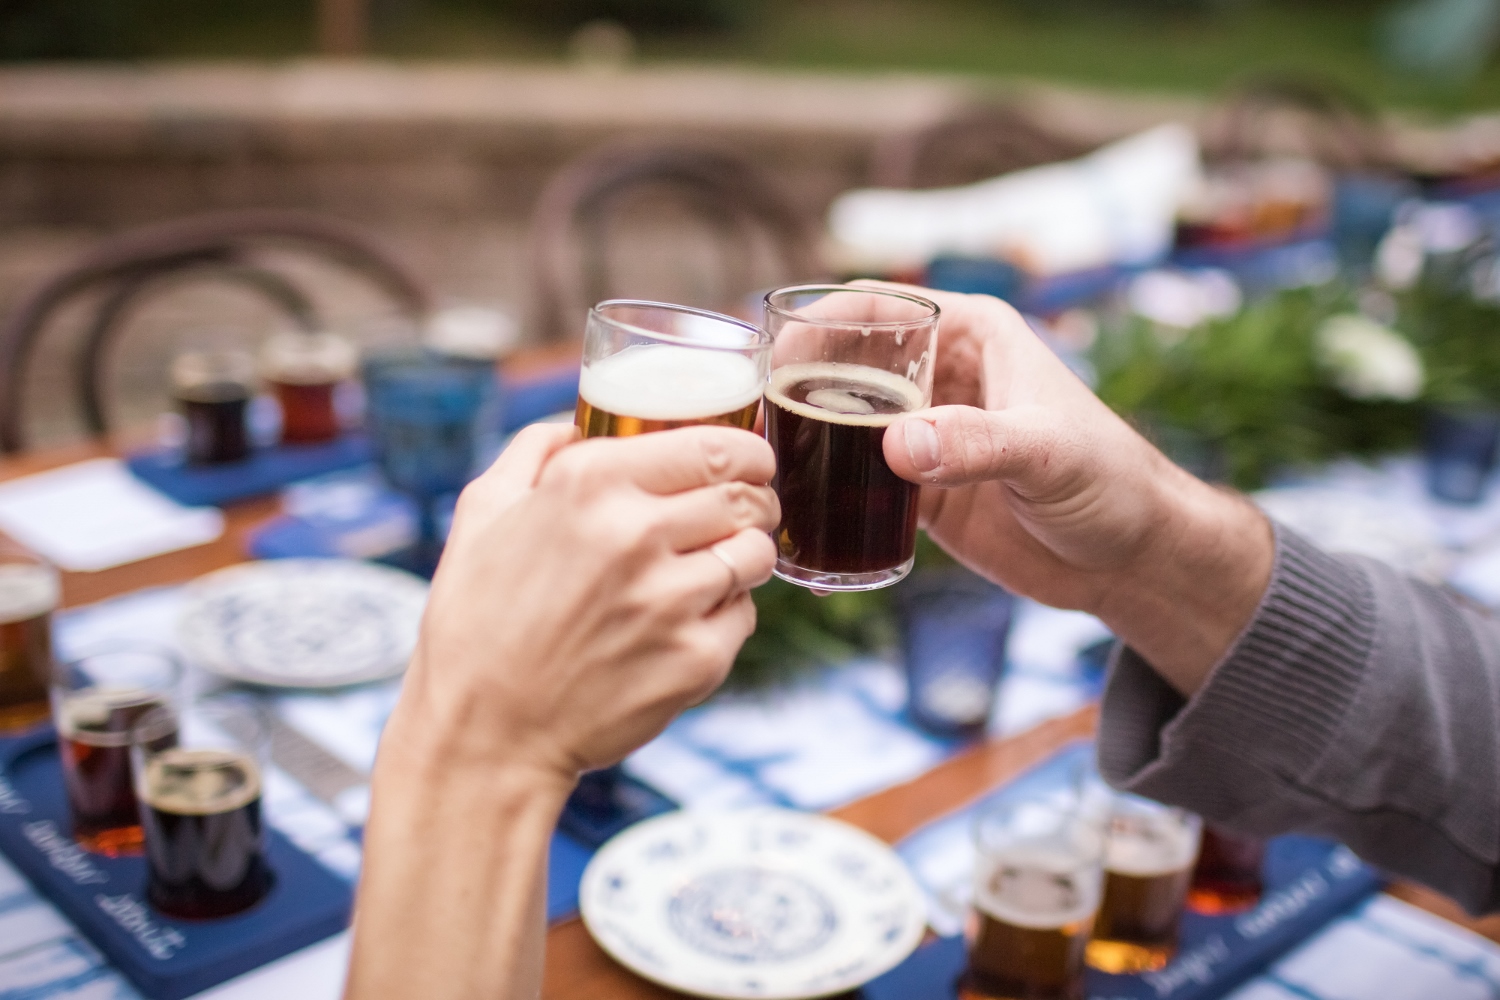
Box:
[579,808,927,1000]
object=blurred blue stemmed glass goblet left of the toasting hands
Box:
[363,348,497,577]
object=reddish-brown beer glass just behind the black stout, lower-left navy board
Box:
[51,646,182,858]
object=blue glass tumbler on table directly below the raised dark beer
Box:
[897,568,1016,738]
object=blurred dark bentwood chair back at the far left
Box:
[0,210,432,453]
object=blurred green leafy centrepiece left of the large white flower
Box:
[1094,289,1419,489]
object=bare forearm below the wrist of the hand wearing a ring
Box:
[345,710,567,1000]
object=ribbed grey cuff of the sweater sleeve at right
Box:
[1098,525,1376,811]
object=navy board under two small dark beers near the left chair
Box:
[125,433,371,507]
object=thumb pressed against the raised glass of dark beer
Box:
[884,406,1050,486]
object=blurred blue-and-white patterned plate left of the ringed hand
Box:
[179,559,428,688]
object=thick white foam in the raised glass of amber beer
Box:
[578,343,764,420]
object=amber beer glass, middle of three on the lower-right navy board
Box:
[1088,795,1202,973]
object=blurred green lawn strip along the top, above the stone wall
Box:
[0,0,1500,112]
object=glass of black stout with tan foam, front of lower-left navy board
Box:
[131,696,273,921]
